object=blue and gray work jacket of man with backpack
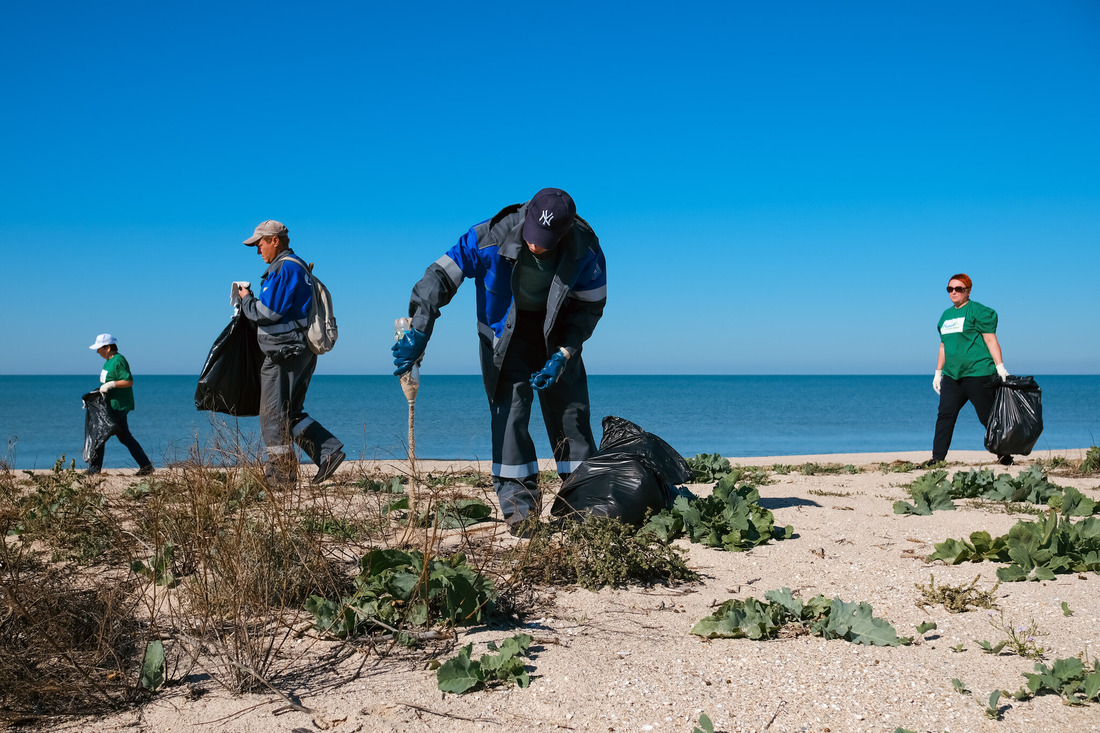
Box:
[241,249,314,354]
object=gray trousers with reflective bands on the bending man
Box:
[490,318,596,518]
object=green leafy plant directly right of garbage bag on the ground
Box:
[642,474,794,551]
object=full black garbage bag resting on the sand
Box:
[550,415,692,526]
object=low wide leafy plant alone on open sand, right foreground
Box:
[691,588,912,646]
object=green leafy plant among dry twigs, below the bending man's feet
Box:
[306,549,496,638]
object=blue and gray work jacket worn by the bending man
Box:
[409,204,607,401]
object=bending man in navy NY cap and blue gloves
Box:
[393,188,607,534]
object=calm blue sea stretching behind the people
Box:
[0,374,1100,469]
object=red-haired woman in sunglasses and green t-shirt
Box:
[925,273,1012,466]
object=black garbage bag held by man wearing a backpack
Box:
[195,314,264,417]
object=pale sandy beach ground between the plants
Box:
[17,450,1100,733]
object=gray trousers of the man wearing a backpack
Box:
[260,347,343,463]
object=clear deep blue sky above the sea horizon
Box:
[0,0,1100,374]
